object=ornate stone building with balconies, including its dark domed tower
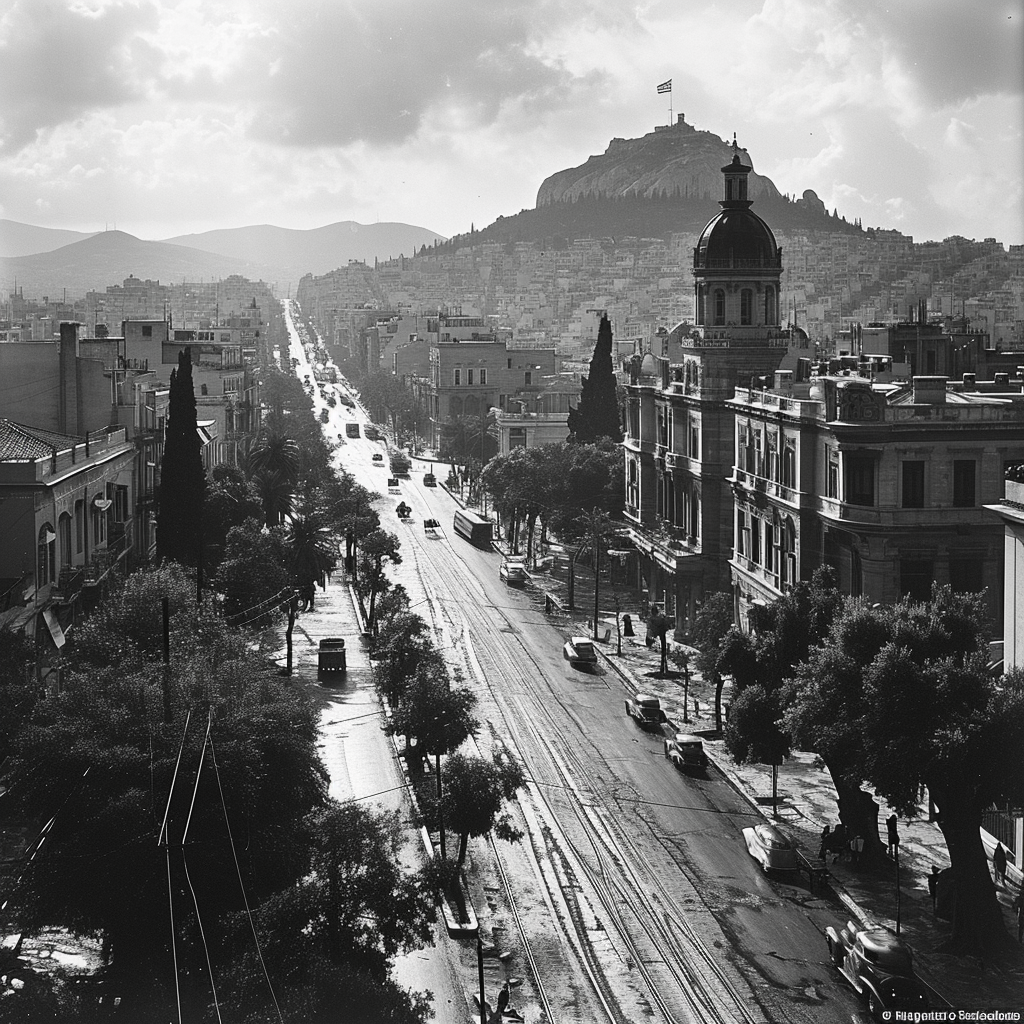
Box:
[623,143,810,636]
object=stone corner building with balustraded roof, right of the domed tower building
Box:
[726,371,1024,626]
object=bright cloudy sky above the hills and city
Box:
[0,0,1024,245]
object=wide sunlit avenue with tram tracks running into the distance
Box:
[284,303,860,1024]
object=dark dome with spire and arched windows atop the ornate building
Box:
[693,138,782,340]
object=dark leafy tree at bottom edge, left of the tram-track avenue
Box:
[220,801,434,1024]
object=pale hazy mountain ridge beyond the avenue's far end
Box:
[165,220,444,283]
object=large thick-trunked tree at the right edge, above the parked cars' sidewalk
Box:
[784,586,1024,953]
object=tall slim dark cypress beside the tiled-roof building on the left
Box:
[157,346,206,565]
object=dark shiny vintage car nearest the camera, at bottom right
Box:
[825,921,928,1021]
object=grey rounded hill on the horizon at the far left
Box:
[0,231,273,298]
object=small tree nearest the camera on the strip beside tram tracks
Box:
[441,753,526,867]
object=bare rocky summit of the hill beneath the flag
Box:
[537,119,779,207]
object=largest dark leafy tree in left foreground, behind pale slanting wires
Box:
[8,589,327,1005]
